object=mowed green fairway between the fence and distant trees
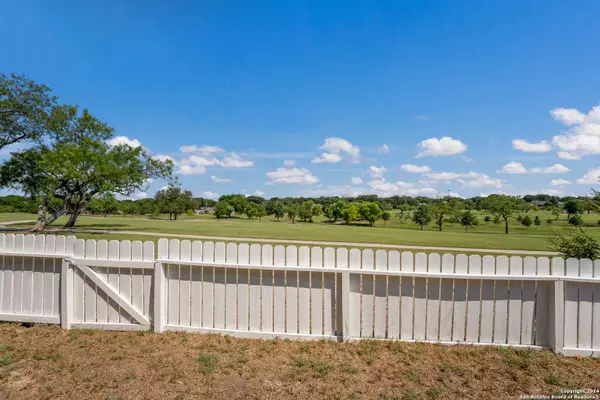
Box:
[0,212,600,251]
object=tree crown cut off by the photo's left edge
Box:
[0,73,57,149]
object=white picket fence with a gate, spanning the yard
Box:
[0,234,600,356]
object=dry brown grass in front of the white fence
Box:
[0,323,600,400]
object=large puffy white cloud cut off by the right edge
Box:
[550,105,600,160]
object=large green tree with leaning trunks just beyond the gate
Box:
[0,106,173,231]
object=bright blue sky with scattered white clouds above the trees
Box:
[0,0,600,197]
